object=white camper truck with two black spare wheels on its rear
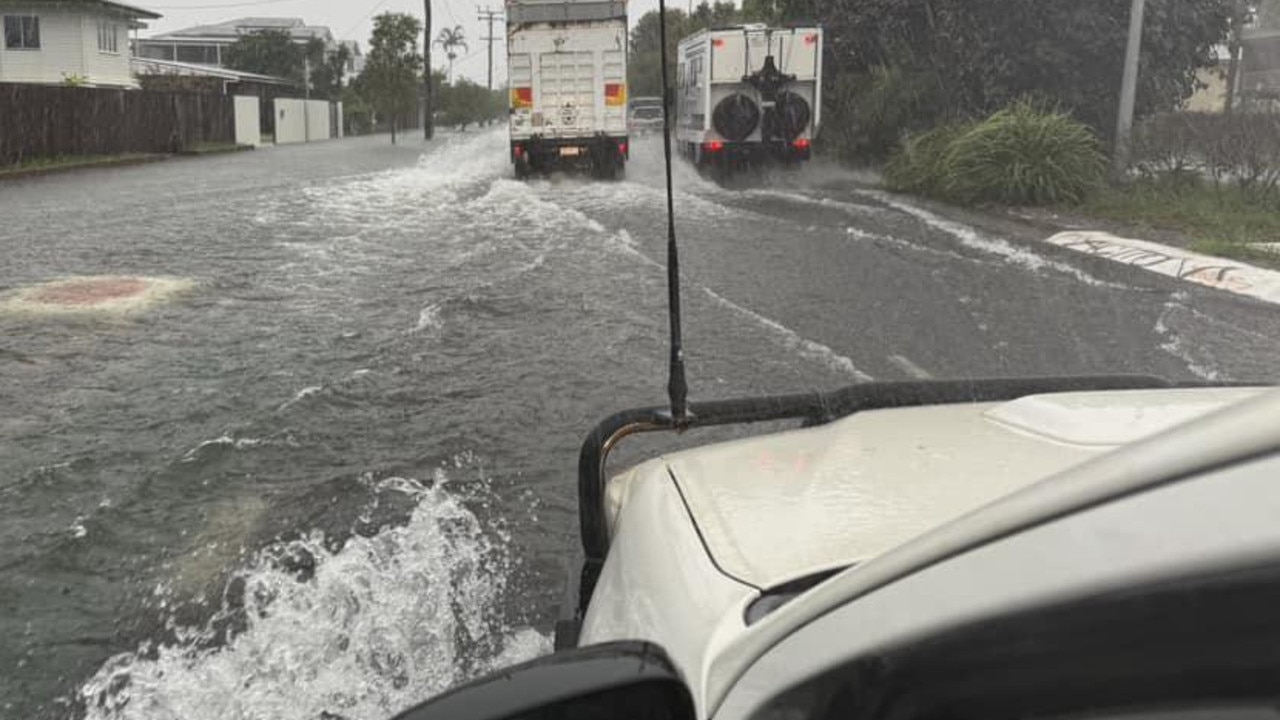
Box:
[676,24,823,170]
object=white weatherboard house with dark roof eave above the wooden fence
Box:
[0,0,160,87]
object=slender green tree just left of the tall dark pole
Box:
[360,13,422,145]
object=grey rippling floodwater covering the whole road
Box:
[0,132,1280,720]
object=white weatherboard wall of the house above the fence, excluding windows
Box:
[0,4,136,87]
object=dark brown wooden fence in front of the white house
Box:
[0,83,236,167]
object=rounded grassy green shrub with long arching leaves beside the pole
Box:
[943,100,1106,205]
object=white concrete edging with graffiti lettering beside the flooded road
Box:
[1046,232,1280,304]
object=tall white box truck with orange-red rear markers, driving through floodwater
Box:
[506,0,630,178]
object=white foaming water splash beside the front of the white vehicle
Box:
[79,479,549,720]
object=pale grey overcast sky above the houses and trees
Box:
[137,0,711,83]
